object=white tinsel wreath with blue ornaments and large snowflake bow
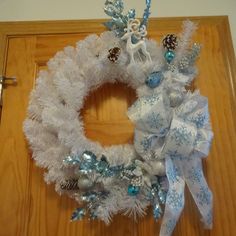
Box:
[24,1,212,235]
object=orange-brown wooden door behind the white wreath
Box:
[0,17,236,236]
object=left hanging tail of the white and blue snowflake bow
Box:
[160,157,185,236]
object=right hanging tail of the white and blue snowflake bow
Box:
[183,157,213,229]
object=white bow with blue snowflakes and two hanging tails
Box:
[128,92,213,236]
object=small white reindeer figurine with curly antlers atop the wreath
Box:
[121,19,152,63]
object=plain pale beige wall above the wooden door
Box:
[0,0,236,50]
